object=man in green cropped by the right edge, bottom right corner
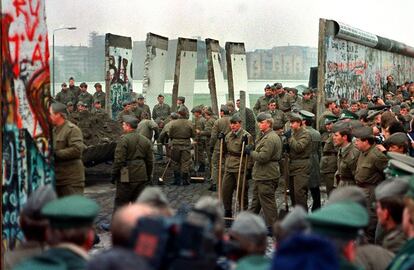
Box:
[387,180,414,270]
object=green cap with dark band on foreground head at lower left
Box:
[41,195,99,228]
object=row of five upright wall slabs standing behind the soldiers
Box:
[105,33,249,115]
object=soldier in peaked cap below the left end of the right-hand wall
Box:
[320,115,338,195]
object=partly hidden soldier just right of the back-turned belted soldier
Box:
[191,106,206,172]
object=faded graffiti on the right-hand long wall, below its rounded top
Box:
[325,36,414,99]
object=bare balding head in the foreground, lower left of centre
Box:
[111,203,156,247]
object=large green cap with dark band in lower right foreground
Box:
[307,201,369,240]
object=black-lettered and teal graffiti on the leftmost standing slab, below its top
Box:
[107,46,132,119]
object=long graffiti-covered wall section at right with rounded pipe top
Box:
[318,19,414,104]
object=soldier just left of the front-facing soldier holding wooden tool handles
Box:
[209,105,230,191]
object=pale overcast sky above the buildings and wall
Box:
[45,0,414,51]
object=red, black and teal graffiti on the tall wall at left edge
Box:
[0,0,54,249]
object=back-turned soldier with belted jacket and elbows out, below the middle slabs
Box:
[167,107,194,185]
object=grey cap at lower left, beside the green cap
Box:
[22,185,57,219]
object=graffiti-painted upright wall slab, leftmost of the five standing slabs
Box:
[105,34,133,119]
